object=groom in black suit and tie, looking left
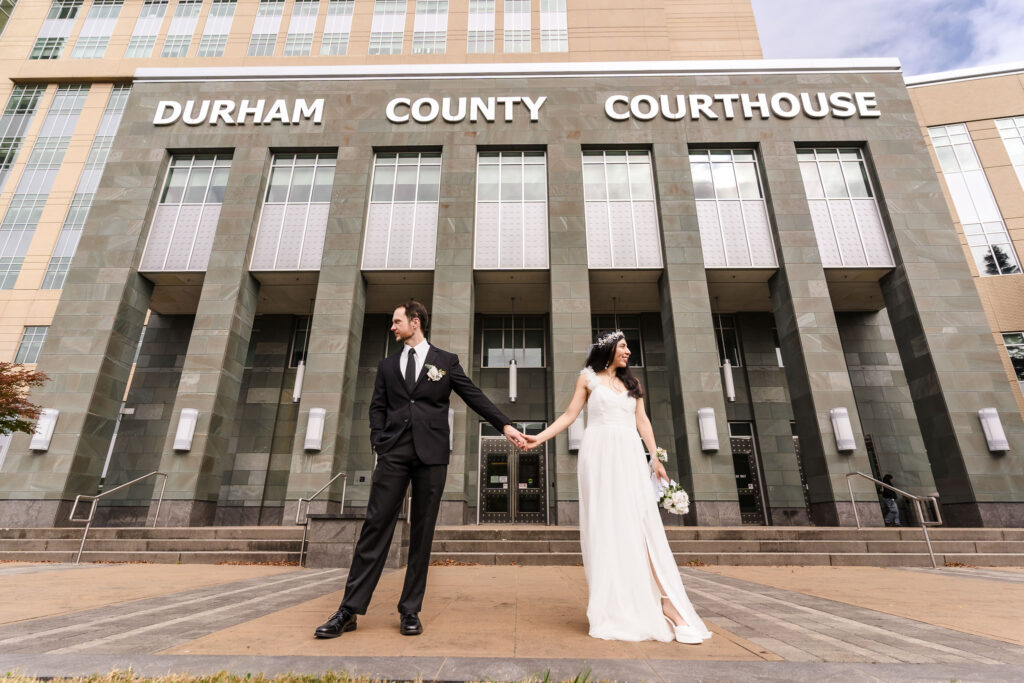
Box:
[314,301,525,638]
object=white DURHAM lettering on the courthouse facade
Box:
[153,98,324,126]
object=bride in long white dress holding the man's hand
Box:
[526,330,711,644]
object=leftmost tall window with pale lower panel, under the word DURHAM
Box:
[139,155,231,272]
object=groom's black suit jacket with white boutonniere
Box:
[370,344,511,465]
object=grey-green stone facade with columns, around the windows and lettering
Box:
[0,63,1024,525]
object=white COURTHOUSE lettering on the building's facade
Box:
[604,92,882,121]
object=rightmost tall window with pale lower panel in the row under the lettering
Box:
[797,147,893,268]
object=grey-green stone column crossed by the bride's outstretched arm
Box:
[548,142,591,525]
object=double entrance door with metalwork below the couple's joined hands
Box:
[478,422,548,524]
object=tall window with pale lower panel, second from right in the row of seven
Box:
[690,150,778,268]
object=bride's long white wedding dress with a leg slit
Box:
[579,368,711,642]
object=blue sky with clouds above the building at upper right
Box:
[753,0,1024,76]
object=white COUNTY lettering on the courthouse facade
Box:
[384,95,548,123]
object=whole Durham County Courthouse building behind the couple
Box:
[0,0,1024,526]
